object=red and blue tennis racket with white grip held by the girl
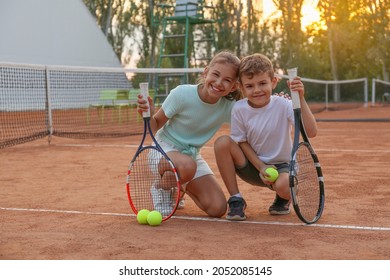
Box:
[126,83,180,221]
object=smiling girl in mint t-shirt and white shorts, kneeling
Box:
[138,51,241,217]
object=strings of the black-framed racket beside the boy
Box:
[294,145,320,221]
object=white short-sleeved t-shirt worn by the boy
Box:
[231,96,294,164]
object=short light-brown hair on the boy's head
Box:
[238,53,274,80]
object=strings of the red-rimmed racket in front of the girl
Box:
[128,148,179,217]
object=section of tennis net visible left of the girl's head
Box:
[0,63,202,149]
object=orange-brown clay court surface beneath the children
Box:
[0,106,390,260]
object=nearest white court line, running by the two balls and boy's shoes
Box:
[0,207,390,231]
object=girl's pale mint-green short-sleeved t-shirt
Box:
[156,85,235,154]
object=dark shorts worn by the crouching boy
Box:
[235,160,290,188]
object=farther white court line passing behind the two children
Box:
[54,144,390,153]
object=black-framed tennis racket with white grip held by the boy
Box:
[287,68,325,224]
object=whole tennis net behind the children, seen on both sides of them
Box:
[0,63,390,149]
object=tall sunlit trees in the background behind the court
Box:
[80,0,390,94]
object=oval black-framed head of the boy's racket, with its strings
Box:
[289,142,325,224]
